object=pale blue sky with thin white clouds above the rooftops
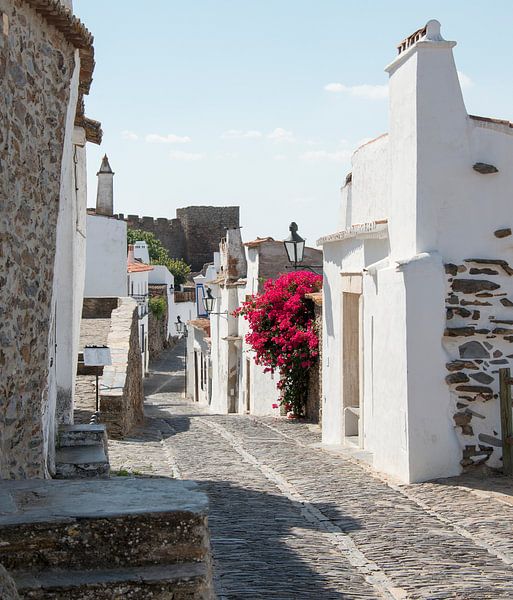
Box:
[74,0,513,245]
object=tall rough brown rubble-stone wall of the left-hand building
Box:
[0,0,75,478]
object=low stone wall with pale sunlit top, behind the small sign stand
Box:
[100,298,144,438]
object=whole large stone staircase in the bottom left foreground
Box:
[0,478,214,600]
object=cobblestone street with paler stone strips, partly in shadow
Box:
[110,344,513,600]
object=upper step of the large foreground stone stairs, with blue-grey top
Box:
[0,477,209,571]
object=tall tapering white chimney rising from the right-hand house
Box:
[385,20,468,259]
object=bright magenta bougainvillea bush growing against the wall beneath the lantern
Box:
[236,271,322,416]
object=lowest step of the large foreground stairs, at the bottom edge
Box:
[13,563,213,600]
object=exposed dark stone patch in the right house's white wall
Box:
[444,241,513,469]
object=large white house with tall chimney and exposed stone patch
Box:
[319,21,513,482]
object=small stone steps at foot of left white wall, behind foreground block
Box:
[55,425,110,479]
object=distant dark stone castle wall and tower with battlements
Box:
[116,206,239,271]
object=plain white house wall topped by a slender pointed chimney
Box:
[84,155,127,297]
